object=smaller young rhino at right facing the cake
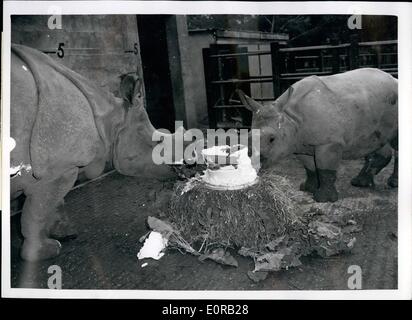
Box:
[238,68,398,202]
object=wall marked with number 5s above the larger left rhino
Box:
[11,15,141,96]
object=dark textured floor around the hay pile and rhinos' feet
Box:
[11,160,397,290]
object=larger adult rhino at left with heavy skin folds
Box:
[11,45,175,261]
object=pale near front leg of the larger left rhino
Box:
[20,168,78,261]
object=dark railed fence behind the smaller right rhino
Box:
[203,37,398,129]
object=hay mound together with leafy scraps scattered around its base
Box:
[148,173,356,280]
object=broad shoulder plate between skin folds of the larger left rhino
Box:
[11,45,105,179]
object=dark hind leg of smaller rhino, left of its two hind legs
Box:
[351,145,392,188]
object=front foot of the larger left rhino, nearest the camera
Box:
[20,239,61,261]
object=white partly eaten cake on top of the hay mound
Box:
[202,145,257,189]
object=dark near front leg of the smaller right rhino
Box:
[313,144,342,202]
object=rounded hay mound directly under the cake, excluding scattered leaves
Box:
[167,175,301,253]
